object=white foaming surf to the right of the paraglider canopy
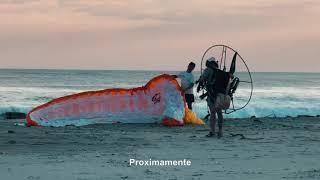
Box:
[194,87,320,118]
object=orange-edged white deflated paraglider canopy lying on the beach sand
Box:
[27,75,201,126]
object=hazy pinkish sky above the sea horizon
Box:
[0,0,320,72]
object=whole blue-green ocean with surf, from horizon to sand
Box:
[0,69,320,118]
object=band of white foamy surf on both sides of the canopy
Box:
[0,87,320,118]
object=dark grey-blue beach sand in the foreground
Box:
[0,117,320,180]
